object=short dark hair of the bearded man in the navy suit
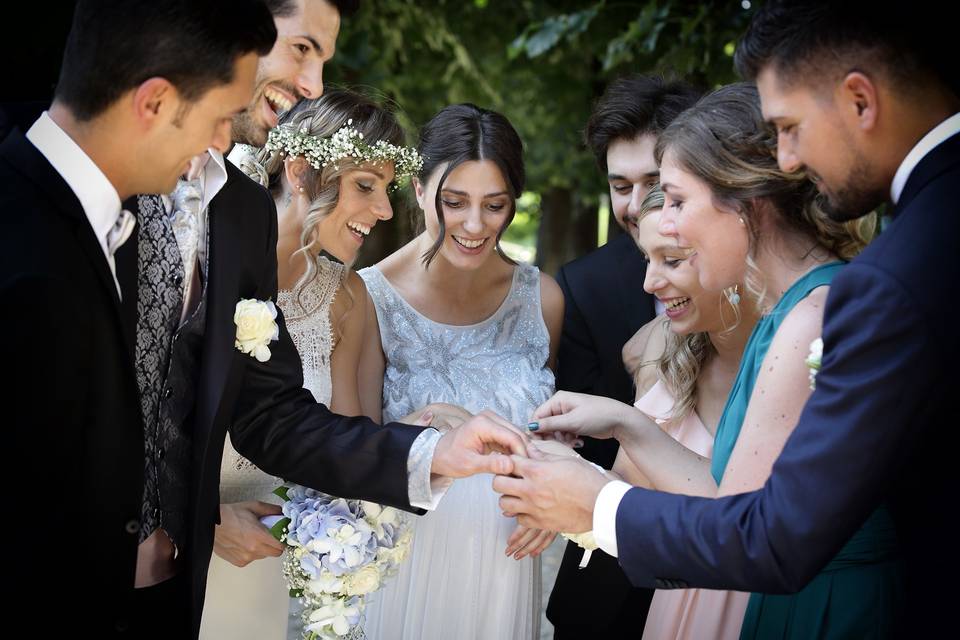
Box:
[734,0,957,92]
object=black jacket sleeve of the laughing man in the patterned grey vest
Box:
[230,178,423,511]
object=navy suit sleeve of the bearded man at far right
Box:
[616,263,932,593]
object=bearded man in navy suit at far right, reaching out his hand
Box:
[495,1,960,637]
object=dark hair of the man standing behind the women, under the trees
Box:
[584,74,701,171]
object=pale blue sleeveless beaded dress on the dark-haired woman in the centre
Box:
[360,264,554,640]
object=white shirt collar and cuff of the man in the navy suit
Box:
[593,113,960,557]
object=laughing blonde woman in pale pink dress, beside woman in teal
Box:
[613,187,758,640]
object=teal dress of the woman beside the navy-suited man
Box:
[711,262,900,640]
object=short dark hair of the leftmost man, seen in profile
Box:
[54,0,277,120]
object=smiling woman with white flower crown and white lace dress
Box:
[200,91,422,640]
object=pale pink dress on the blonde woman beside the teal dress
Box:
[634,381,750,640]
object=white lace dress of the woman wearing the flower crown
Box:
[200,257,345,640]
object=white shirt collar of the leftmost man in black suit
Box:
[27,111,136,295]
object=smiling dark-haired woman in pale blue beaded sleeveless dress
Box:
[360,104,563,640]
